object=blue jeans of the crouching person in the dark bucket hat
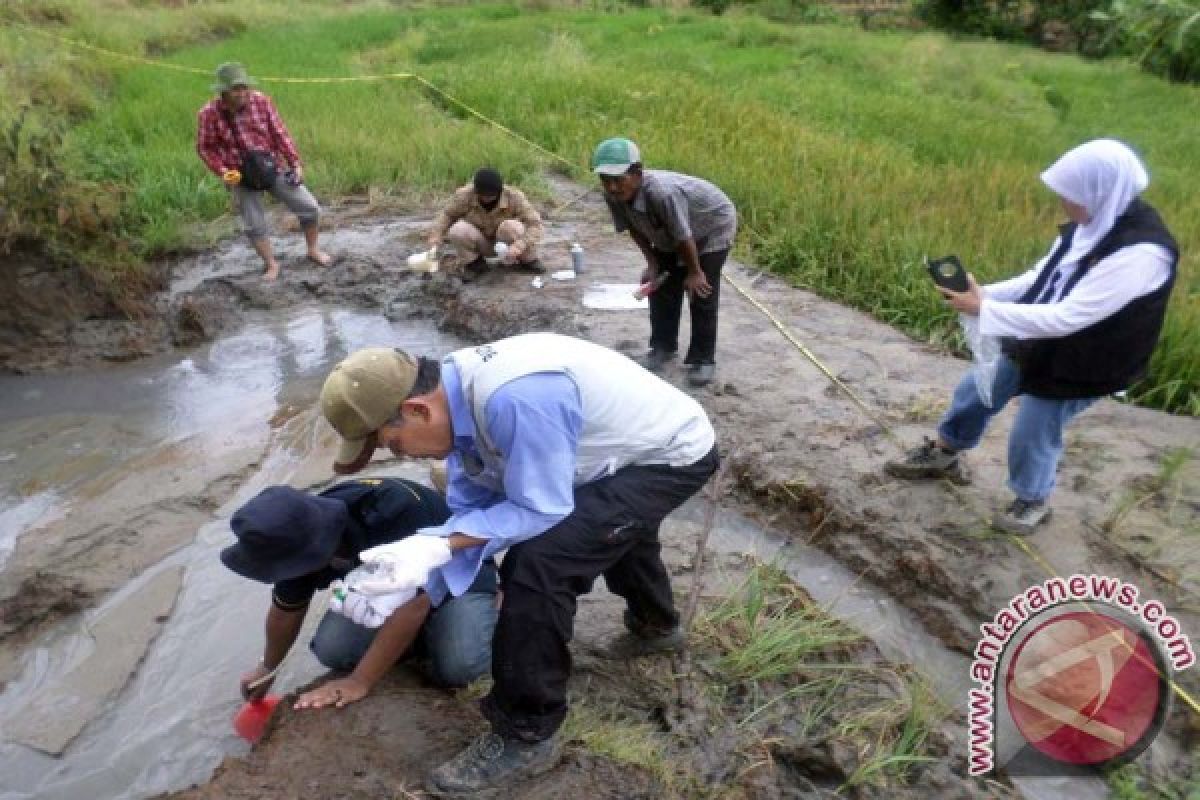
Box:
[308,593,498,686]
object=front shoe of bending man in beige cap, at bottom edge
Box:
[425,732,563,798]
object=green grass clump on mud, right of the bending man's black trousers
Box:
[695,565,947,792]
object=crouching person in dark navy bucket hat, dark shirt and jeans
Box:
[221,477,498,708]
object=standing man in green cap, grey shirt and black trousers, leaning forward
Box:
[592,138,738,386]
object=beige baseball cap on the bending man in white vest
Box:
[320,348,416,475]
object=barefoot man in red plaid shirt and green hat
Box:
[196,62,330,281]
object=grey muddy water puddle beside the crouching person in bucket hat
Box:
[0,309,460,800]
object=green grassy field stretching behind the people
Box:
[0,0,1200,414]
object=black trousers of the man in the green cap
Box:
[650,249,730,363]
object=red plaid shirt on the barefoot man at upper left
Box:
[196,91,300,175]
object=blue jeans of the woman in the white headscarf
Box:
[937,357,1097,503]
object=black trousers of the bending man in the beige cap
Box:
[481,447,719,741]
